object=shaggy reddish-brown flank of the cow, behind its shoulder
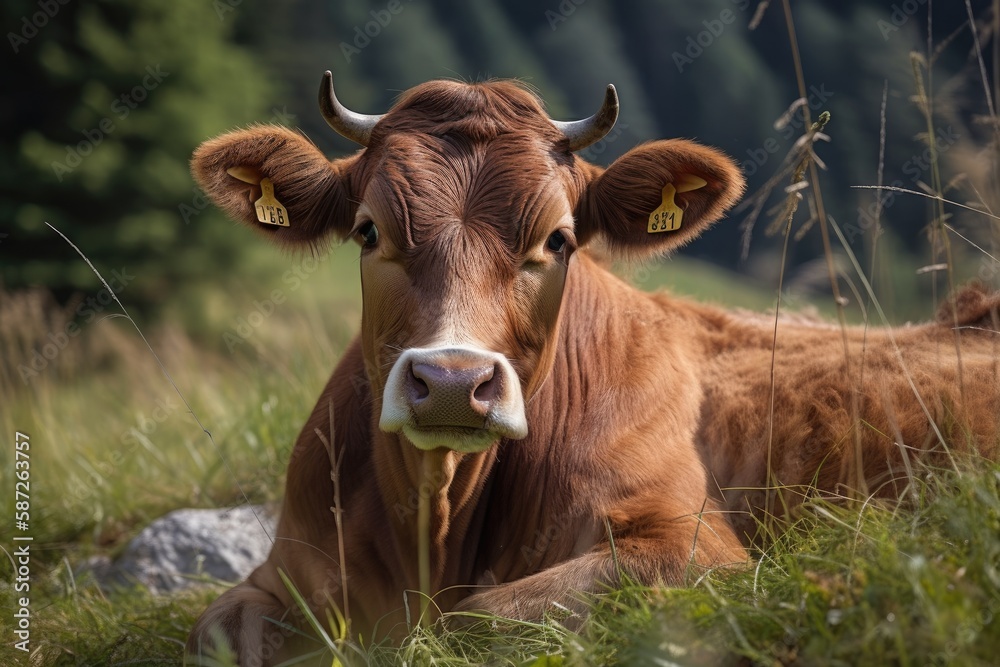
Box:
[692,286,1000,540]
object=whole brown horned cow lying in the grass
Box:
[182,73,1000,665]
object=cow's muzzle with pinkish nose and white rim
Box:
[379,346,528,452]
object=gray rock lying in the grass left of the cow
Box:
[84,505,277,594]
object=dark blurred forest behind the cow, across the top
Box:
[0,0,998,362]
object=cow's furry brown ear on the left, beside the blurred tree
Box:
[191,125,357,247]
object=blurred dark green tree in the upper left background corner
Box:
[0,0,281,306]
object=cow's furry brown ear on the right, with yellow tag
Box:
[576,139,745,259]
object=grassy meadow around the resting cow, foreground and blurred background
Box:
[0,3,1000,667]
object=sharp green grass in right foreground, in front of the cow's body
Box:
[276,462,1000,666]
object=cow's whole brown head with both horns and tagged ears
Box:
[193,72,743,452]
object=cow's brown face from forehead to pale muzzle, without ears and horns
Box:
[352,129,577,451]
